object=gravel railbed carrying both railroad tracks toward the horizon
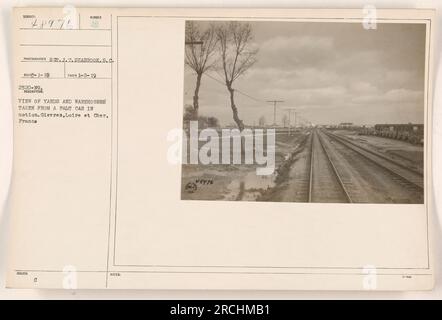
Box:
[260,129,424,203]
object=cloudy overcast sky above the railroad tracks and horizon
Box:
[184,22,425,125]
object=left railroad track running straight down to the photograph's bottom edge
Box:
[308,129,353,203]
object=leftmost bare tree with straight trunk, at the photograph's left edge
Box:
[185,21,217,119]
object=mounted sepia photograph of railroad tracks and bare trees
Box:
[181,20,426,204]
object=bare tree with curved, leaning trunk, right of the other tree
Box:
[216,21,258,130]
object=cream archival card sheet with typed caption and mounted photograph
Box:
[7,6,435,290]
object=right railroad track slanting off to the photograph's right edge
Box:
[321,130,424,190]
